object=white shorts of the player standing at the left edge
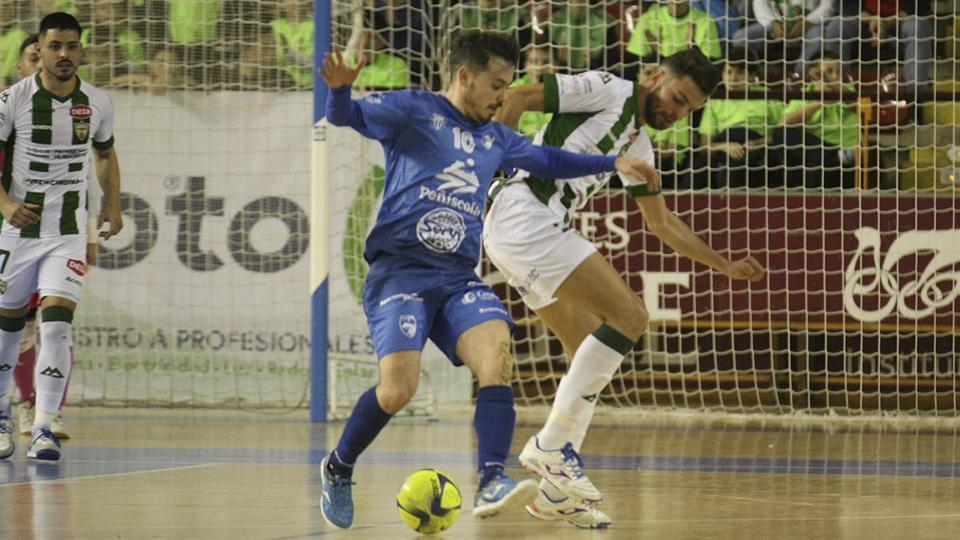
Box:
[0,234,87,309]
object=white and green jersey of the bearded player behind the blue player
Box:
[509,71,656,224]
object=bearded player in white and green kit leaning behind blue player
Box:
[484,49,764,528]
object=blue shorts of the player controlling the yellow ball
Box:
[363,261,515,366]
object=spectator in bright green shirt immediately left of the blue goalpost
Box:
[270,0,313,88]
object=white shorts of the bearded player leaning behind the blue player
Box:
[483,182,597,309]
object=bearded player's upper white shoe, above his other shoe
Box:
[519,435,603,502]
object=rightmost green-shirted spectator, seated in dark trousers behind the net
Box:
[783,51,860,188]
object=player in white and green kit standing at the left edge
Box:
[0,13,123,460]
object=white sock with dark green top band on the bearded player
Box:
[537,325,633,450]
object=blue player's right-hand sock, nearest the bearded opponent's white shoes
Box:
[473,386,517,487]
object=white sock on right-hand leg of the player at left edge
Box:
[33,321,73,431]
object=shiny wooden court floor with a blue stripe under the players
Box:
[0,408,960,540]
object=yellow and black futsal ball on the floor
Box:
[397,469,461,534]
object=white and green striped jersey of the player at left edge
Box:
[0,75,113,238]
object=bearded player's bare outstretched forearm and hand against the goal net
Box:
[633,194,765,281]
